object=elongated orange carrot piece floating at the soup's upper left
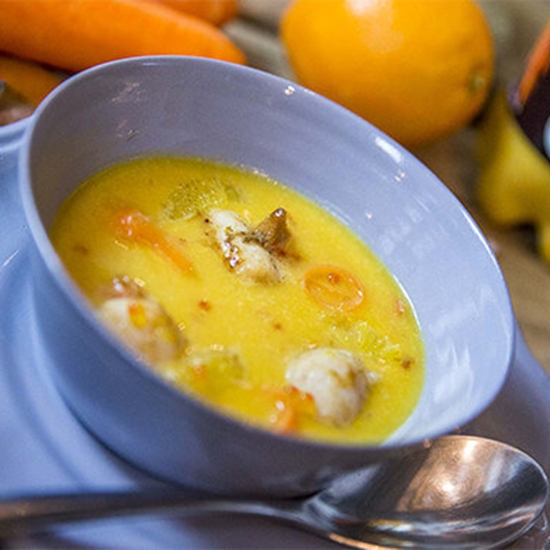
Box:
[116,210,193,273]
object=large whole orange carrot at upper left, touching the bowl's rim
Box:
[0,0,245,72]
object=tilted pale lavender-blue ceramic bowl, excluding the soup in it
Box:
[20,57,514,496]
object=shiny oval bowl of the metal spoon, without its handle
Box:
[309,436,548,548]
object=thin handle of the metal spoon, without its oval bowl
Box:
[0,490,302,538]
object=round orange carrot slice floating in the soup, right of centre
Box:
[304,265,365,311]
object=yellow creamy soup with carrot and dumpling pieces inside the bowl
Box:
[51,157,424,444]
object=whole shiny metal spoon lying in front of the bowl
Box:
[0,436,548,549]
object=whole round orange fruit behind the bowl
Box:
[281,0,494,147]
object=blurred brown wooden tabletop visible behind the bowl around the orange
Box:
[228,0,550,373]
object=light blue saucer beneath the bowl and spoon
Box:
[0,108,550,549]
